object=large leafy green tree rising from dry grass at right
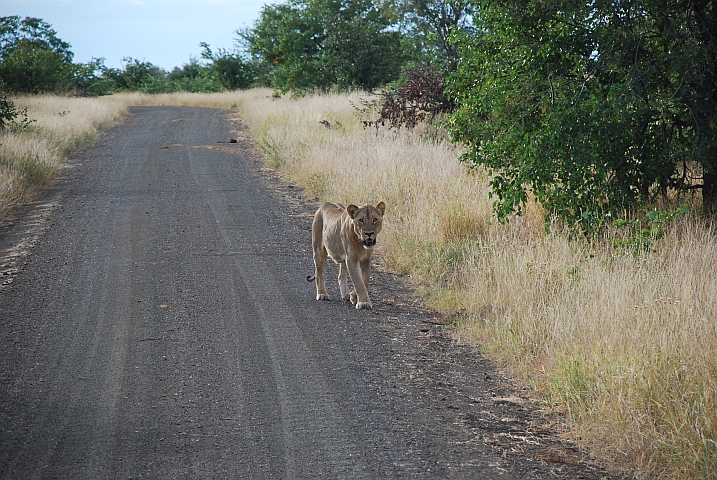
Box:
[449,0,717,230]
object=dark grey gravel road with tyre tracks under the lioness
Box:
[0,107,620,479]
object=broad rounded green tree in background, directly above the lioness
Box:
[240,0,405,91]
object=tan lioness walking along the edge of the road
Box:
[306,202,386,309]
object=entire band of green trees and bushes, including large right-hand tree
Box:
[0,0,717,226]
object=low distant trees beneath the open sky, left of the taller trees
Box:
[0,16,256,96]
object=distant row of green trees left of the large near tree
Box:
[0,0,472,95]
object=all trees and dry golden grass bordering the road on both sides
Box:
[0,0,717,479]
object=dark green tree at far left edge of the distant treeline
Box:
[0,16,73,93]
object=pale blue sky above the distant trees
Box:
[0,0,268,71]
